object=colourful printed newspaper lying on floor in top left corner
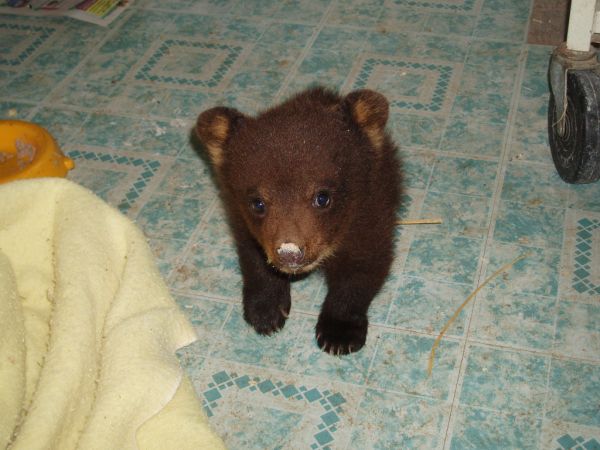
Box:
[0,0,133,26]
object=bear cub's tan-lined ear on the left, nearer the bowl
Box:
[196,106,244,167]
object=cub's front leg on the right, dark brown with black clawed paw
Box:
[316,255,391,355]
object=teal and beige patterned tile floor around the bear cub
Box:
[0,0,600,450]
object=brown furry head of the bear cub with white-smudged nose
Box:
[196,88,391,273]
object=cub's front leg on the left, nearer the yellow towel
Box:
[238,238,292,335]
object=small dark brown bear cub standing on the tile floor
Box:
[196,88,400,355]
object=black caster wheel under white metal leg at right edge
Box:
[548,46,600,184]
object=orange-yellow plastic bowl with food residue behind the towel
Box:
[0,120,75,183]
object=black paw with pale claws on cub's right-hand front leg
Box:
[316,314,369,355]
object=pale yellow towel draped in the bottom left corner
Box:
[0,178,224,450]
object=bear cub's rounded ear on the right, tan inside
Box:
[344,89,389,150]
